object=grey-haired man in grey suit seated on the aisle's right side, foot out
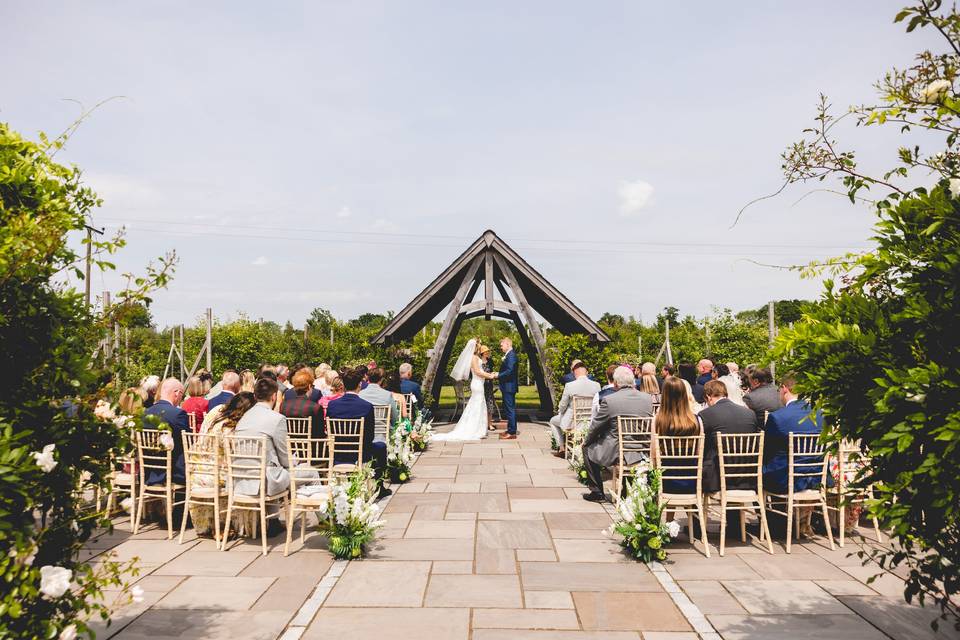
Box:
[583,367,653,502]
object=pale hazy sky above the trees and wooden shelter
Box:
[0,0,938,326]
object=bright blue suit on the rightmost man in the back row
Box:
[763,400,823,493]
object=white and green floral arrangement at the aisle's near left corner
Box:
[317,463,385,560]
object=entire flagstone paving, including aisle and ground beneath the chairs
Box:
[85,424,960,640]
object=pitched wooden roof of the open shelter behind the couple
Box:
[373,230,610,344]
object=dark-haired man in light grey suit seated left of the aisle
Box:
[233,378,290,537]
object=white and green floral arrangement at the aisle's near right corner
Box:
[608,464,680,562]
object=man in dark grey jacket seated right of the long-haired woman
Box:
[699,380,758,493]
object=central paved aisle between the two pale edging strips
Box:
[302,424,697,640]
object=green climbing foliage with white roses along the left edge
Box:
[0,123,173,639]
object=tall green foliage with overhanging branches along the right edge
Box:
[775,0,960,628]
